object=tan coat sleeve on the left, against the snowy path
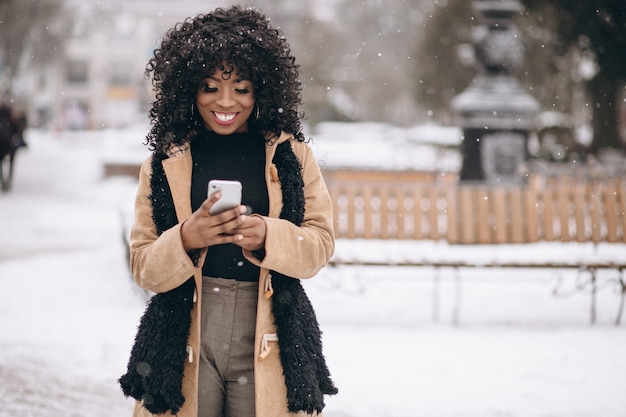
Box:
[130,159,196,293]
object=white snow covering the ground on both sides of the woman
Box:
[0,129,626,417]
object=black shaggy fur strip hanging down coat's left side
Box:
[119,153,194,414]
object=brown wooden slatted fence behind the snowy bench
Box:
[324,171,626,244]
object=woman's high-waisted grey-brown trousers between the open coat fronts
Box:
[198,277,259,417]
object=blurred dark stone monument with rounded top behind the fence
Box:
[452,0,539,185]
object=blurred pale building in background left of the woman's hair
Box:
[27,0,224,129]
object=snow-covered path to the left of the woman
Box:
[0,135,143,417]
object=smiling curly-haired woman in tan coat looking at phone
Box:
[120,6,337,417]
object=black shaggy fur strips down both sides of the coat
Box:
[119,142,337,414]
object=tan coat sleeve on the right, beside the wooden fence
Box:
[244,141,335,278]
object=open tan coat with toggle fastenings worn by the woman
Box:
[130,133,334,417]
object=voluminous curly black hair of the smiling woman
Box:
[146,6,305,151]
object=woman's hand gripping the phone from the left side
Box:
[180,192,247,251]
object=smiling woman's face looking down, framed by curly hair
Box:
[196,65,254,135]
